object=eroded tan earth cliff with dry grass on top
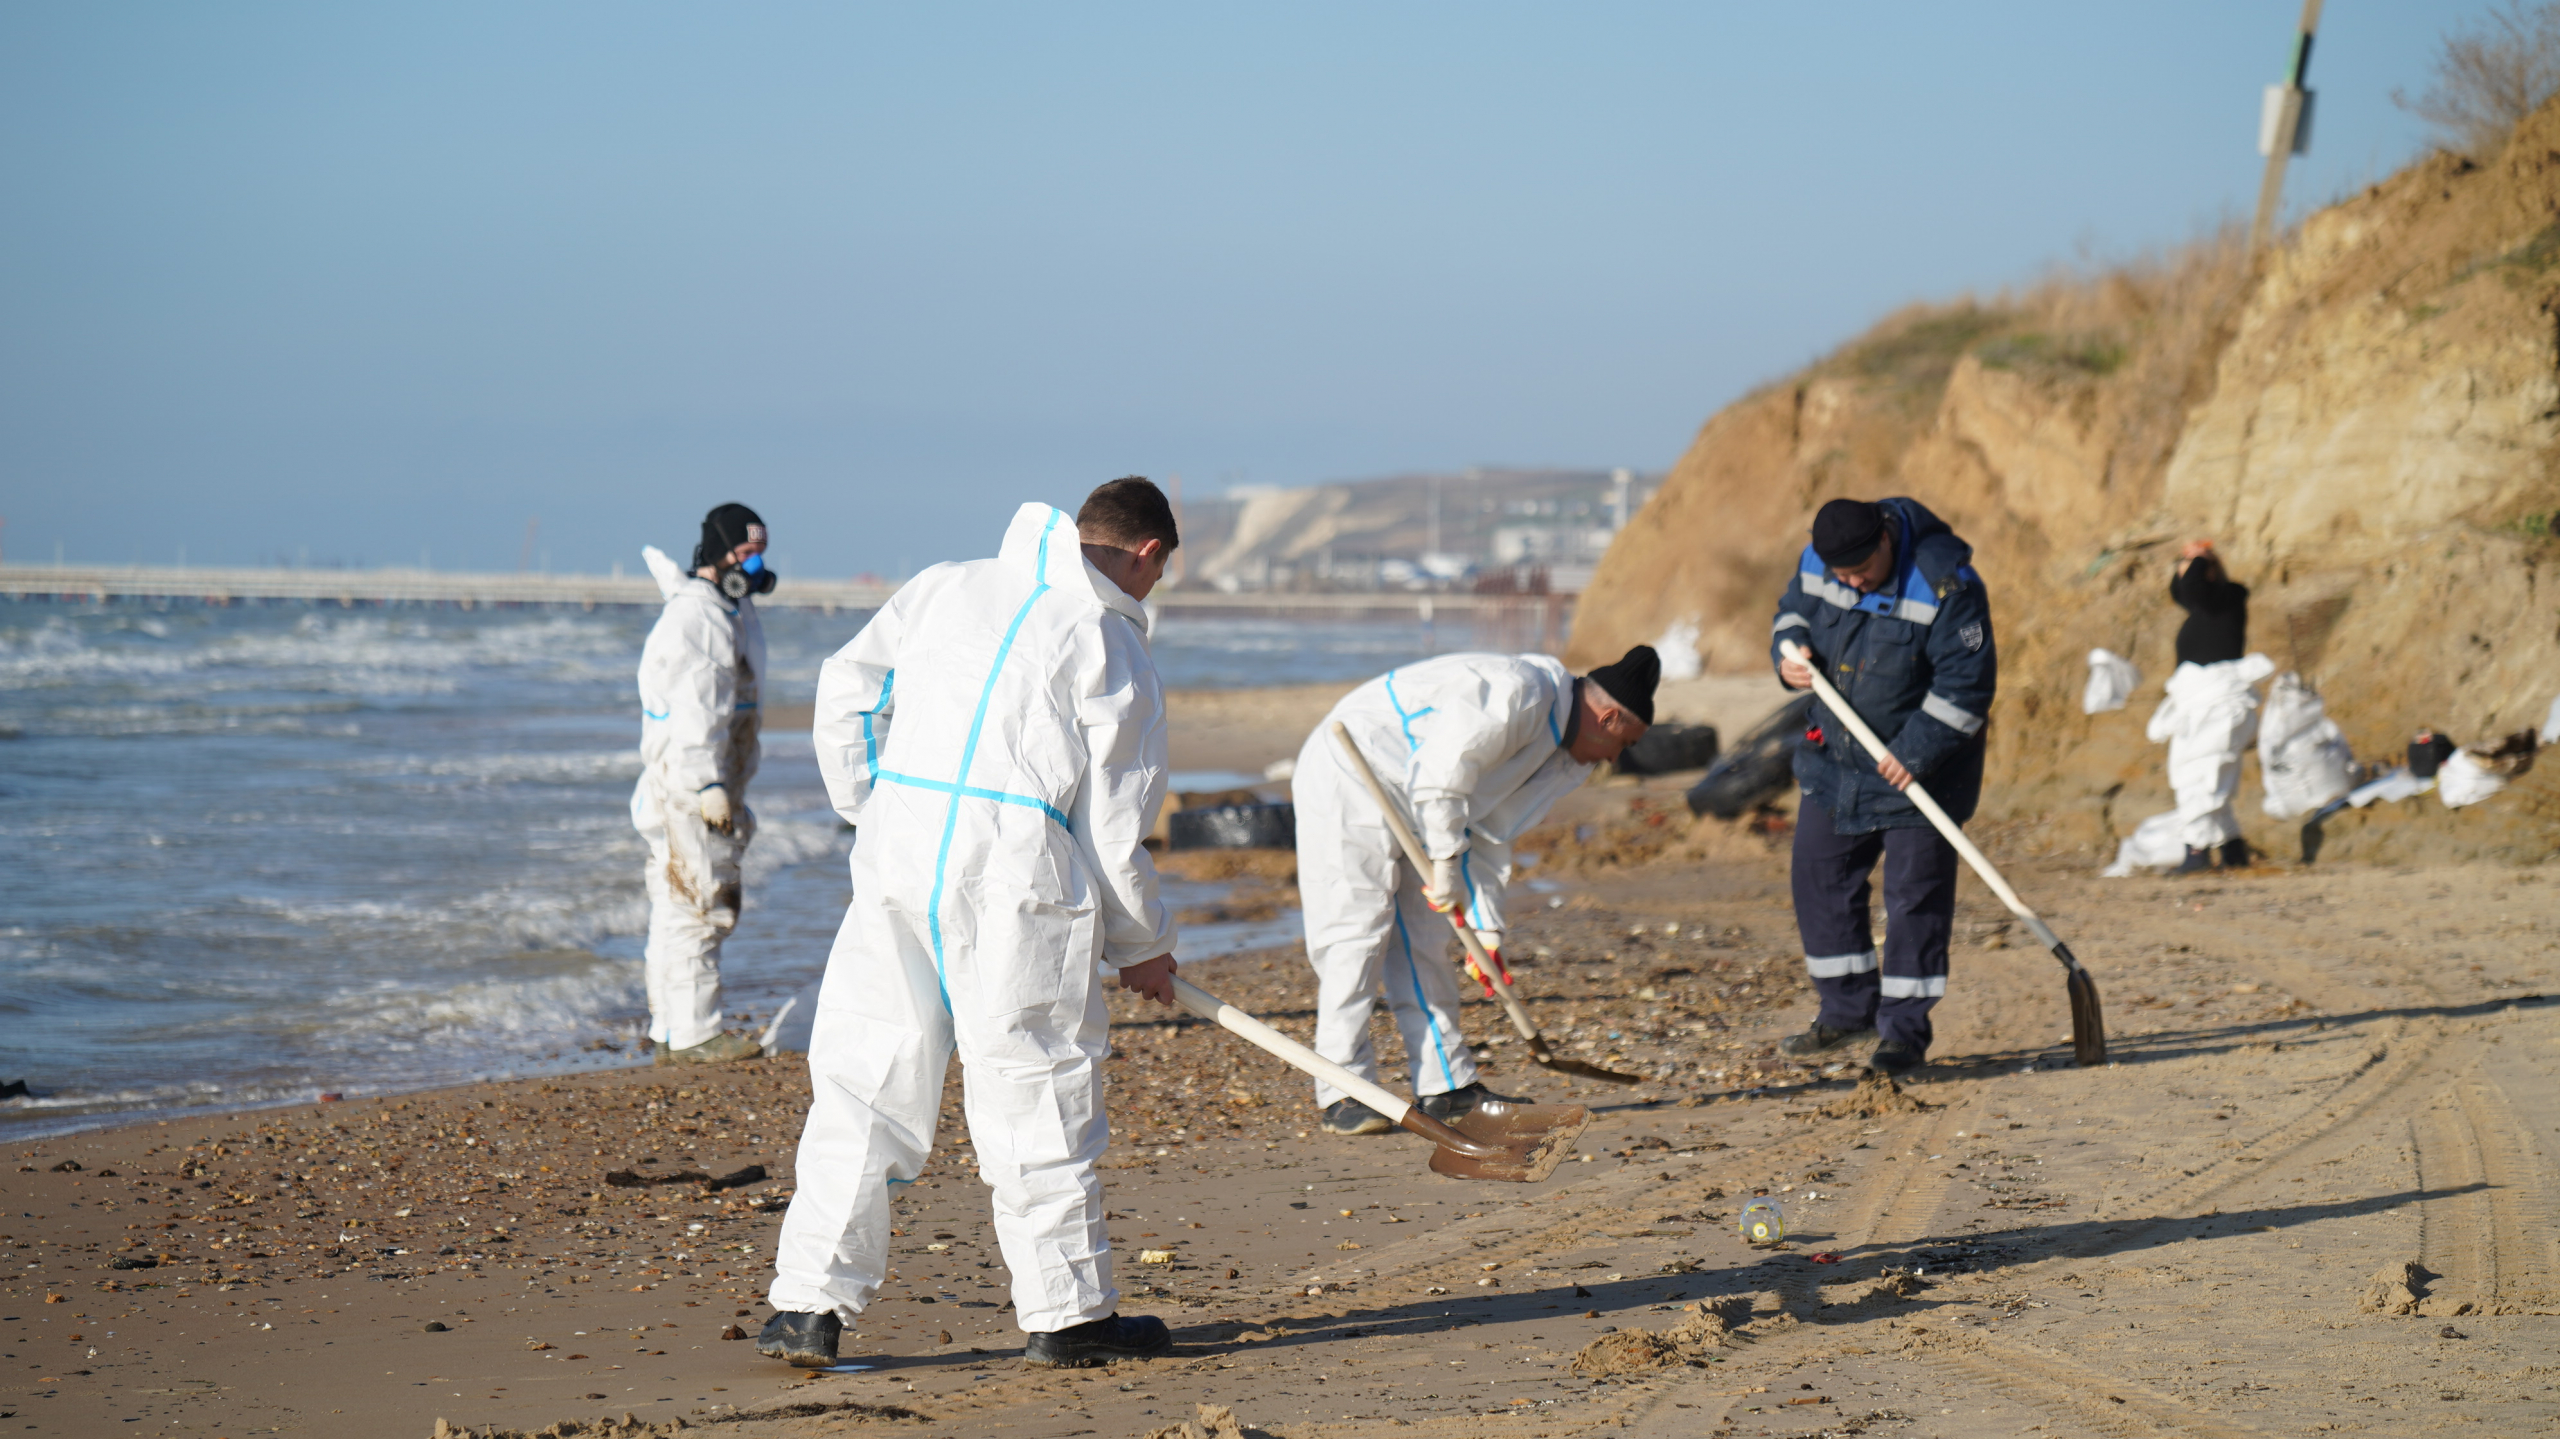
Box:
[1572,105,2560,858]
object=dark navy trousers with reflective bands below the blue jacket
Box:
[1789,799,1956,1052]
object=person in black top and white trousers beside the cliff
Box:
[2145,540,2276,873]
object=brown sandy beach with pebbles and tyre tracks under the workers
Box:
[0,691,2560,1439]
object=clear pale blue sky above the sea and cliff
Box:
[0,0,2519,574]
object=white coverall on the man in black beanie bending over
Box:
[1293,655,1592,1106]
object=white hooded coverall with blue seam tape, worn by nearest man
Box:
[771,504,1175,1331]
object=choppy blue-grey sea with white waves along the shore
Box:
[0,602,1469,1137]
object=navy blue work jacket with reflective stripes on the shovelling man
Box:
[1769,499,1999,835]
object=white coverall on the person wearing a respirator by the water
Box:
[632,576,765,1050]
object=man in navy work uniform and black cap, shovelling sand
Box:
[1769,499,1999,1075]
